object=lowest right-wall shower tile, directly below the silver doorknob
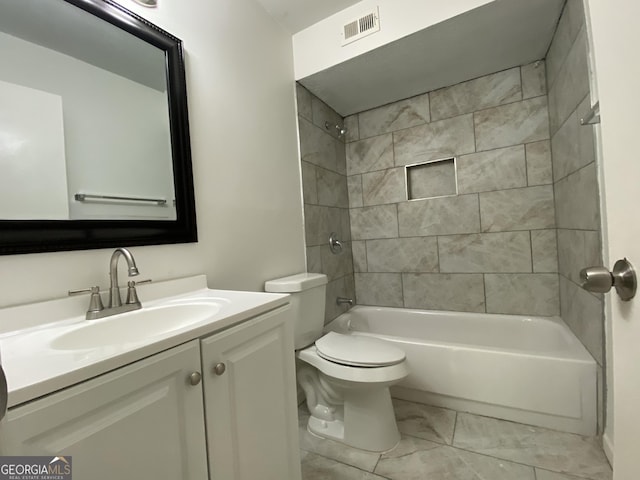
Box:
[560,275,604,365]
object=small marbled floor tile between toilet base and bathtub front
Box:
[393,399,456,444]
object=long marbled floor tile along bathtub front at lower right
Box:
[454,413,611,480]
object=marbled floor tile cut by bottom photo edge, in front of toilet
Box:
[375,446,535,480]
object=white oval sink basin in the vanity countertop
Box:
[50,301,221,350]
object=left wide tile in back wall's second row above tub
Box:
[367,237,438,272]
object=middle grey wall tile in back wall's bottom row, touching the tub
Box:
[402,273,485,312]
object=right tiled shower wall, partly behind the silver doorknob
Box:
[547,0,604,414]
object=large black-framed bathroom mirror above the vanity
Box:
[0,0,197,255]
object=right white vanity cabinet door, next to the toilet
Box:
[201,305,300,480]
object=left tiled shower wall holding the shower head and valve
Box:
[296,85,355,322]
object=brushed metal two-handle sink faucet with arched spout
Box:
[69,248,151,320]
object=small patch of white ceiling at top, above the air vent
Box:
[257,0,360,34]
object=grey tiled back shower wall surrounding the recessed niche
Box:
[346,61,560,315]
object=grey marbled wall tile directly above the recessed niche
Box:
[393,115,475,166]
